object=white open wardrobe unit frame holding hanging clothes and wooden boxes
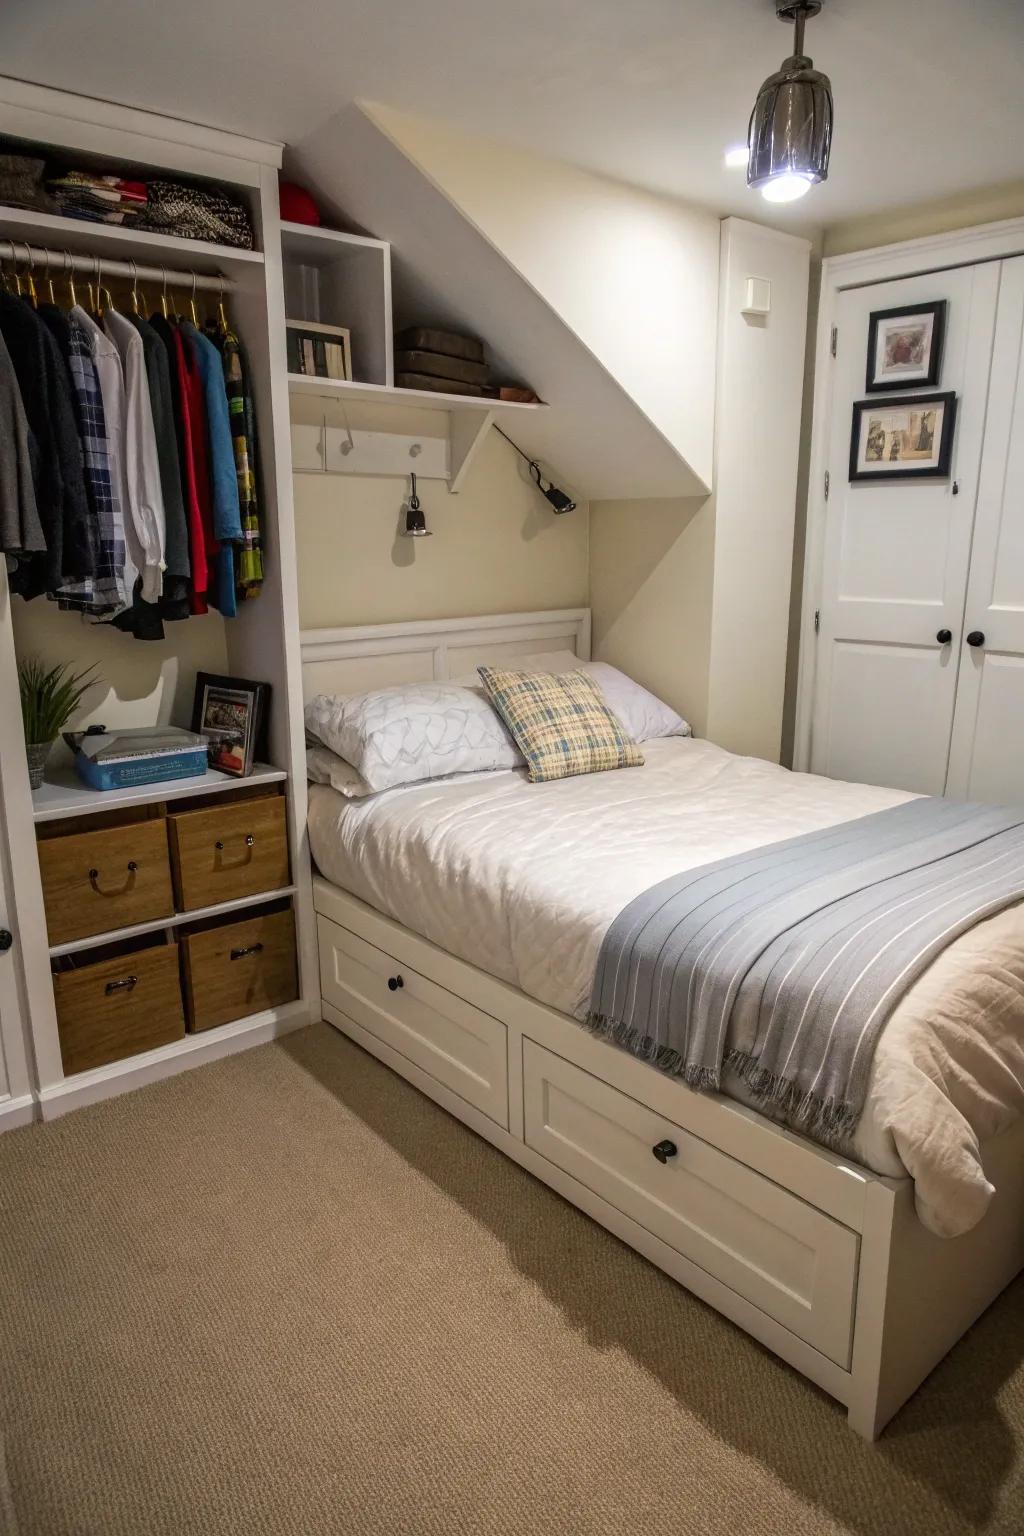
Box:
[0,80,319,1126]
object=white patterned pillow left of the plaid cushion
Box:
[306,682,522,790]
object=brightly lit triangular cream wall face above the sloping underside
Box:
[367,104,718,485]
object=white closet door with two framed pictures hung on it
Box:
[811,264,999,794]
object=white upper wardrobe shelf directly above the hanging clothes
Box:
[0,207,263,284]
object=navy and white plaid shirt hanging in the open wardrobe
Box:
[57,318,130,614]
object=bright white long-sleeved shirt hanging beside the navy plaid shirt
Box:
[103,309,167,602]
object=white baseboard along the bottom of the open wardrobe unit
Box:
[38,1000,310,1120]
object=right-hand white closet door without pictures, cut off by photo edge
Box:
[949,257,1024,803]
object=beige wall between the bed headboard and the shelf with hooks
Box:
[295,432,588,628]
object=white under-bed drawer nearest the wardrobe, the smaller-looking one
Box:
[318,917,508,1129]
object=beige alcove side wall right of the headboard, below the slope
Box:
[590,498,714,736]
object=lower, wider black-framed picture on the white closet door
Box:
[851,390,956,481]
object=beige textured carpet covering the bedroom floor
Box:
[0,1026,1024,1536]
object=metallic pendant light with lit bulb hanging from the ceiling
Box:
[746,0,832,203]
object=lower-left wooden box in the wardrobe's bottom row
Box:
[54,940,184,1077]
